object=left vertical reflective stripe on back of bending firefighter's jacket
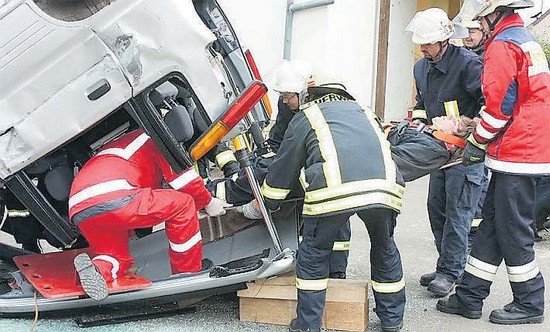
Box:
[303,104,342,187]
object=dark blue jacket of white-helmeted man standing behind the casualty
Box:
[414,44,484,124]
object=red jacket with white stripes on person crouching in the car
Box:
[69,130,212,218]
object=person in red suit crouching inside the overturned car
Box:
[69,130,226,299]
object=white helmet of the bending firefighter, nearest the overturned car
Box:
[273,60,313,93]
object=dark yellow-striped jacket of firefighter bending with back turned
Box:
[262,101,404,216]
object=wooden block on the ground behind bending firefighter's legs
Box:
[237,274,369,331]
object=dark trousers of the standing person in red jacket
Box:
[456,172,544,314]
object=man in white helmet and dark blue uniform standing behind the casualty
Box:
[406,8,483,296]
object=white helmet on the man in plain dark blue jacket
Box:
[405,8,455,45]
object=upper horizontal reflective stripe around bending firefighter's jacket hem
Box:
[305,179,405,202]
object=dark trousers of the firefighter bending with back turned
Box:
[296,208,405,328]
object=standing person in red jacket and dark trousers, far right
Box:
[437,0,550,325]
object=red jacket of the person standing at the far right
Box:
[474,14,550,175]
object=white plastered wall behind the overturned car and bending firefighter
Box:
[219,0,416,120]
